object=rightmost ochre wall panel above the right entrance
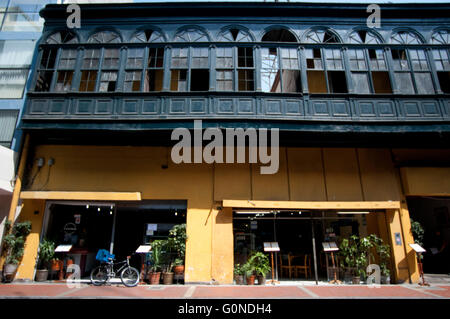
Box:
[357,149,400,200]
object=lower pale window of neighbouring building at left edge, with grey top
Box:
[0,70,28,99]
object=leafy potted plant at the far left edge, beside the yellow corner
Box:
[2,221,31,282]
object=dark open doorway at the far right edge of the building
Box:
[407,197,450,278]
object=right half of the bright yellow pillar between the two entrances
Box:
[211,207,234,284]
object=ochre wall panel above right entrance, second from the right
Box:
[323,148,363,201]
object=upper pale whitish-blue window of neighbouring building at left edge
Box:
[0,40,36,68]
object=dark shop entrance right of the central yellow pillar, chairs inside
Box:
[233,210,369,282]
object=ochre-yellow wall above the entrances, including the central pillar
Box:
[18,145,418,283]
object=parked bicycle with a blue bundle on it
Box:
[90,249,140,287]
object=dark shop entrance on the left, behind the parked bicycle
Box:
[42,200,187,278]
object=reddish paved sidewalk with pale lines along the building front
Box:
[0,283,450,299]
